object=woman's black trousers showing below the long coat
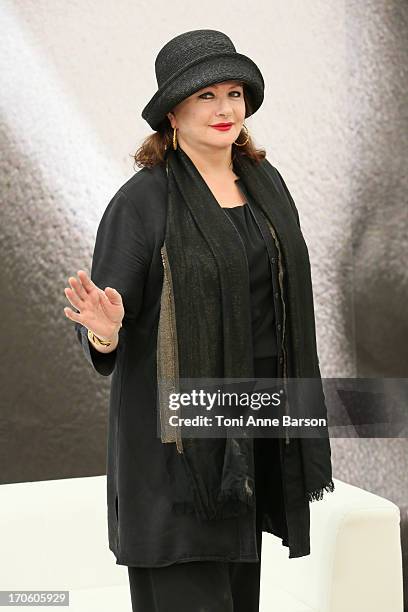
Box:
[128,357,277,612]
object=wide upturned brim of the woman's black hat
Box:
[142,53,265,130]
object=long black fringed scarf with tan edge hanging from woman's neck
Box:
[158,146,334,520]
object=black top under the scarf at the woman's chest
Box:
[223,204,277,359]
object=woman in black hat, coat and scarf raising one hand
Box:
[65,30,334,612]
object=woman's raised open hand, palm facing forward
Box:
[64,270,125,340]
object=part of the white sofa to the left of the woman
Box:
[0,476,132,612]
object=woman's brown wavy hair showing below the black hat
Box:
[131,85,266,170]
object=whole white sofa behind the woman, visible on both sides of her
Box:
[0,476,403,612]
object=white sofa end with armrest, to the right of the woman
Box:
[260,479,403,612]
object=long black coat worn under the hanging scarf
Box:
[75,161,310,567]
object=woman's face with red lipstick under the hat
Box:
[167,81,245,153]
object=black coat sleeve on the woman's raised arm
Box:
[75,189,151,376]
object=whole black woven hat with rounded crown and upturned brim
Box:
[142,30,265,130]
